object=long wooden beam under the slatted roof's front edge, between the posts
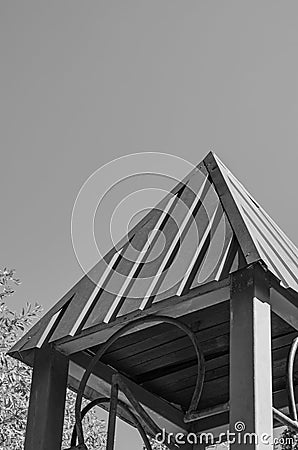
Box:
[55,279,230,354]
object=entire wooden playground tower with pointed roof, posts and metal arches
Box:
[10,153,298,450]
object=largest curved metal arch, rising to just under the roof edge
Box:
[75,315,205,445]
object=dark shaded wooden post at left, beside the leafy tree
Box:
[25,346,68,450]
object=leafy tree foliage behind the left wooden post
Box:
[0,268,106,450]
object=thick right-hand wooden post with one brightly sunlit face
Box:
[230,263,273,450]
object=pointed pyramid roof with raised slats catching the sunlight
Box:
[10,153,298,363]
